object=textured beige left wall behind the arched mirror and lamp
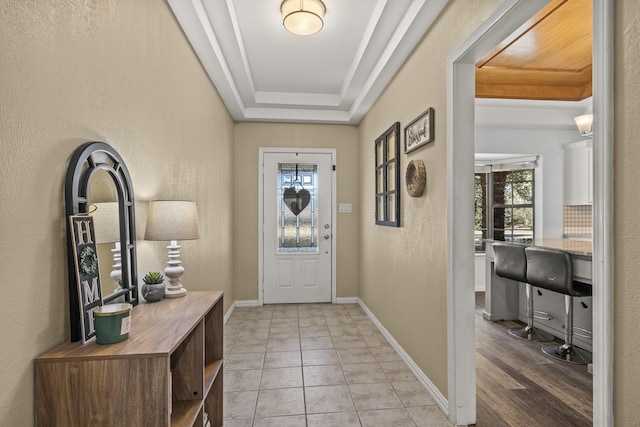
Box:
[0,0,233,426]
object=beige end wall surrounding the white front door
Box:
[234,123,360,300]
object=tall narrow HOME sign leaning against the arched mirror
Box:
[69,214,102,343]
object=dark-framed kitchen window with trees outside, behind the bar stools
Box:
[474,163,535,252]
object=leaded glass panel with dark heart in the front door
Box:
[276,163,318,252]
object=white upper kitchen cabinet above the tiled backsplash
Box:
[564,140,593,205]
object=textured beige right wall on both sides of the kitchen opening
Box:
[359,0,640,426]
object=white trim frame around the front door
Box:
[258,147,338,305]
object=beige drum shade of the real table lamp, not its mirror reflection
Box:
[144,200,200,241]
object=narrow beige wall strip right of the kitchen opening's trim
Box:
[613,0,640,426]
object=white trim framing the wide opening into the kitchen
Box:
[447,0,613,426]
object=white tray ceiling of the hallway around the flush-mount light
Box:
[168,0,448,124]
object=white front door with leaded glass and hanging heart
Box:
[262,152,333,304]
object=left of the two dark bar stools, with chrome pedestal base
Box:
[492,242,553,342]
